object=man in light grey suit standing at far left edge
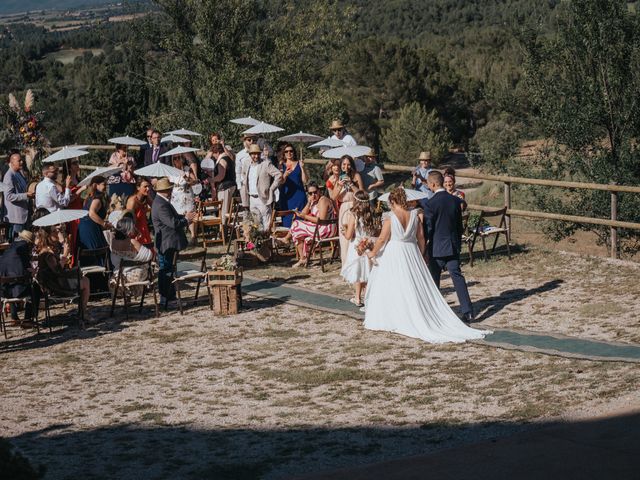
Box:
[2,153,35,241]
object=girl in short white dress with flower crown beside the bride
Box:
[340,190,380,307]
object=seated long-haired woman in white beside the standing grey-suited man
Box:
[110,214,153,297]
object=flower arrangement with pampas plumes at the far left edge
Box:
[0,90,49,171]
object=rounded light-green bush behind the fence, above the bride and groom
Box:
[382,102,451,165]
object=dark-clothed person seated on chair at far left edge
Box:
[0,230,40,328]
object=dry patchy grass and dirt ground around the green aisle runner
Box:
[0,248,640,479]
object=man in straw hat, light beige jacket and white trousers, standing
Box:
[240,144,282,231]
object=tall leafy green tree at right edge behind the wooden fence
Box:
[524,0,640,253]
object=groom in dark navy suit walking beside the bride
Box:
[424,170,474,324]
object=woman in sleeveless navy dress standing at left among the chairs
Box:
[78,175,111,253]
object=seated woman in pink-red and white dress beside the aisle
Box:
[278,182,338,268]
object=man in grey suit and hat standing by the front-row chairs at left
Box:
[151,178,196,305]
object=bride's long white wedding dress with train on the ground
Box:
[364,210,492,343]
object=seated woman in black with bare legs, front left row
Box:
[35,229,95,323]
